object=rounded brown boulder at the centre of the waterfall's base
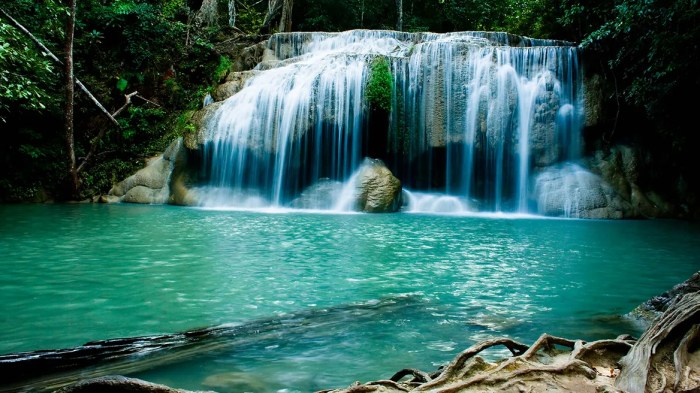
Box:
[355,158,401,213]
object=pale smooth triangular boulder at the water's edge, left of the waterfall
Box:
[104,139,183,204]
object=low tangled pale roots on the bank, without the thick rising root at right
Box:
[322,334,634,393]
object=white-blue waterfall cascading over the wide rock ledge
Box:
[201,30,583,213]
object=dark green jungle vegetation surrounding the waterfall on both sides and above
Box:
[0,0,700,202]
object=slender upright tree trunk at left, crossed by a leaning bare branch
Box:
[65,0,80,198]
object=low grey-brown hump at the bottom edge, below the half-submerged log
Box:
[54,375,213,393]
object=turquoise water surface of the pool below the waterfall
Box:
[0,205,700,392]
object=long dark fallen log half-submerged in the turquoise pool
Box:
[0,294,424,392]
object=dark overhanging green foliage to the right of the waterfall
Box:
[560,0,700,194]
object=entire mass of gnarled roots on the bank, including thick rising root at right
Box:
[319,273,700,393]
